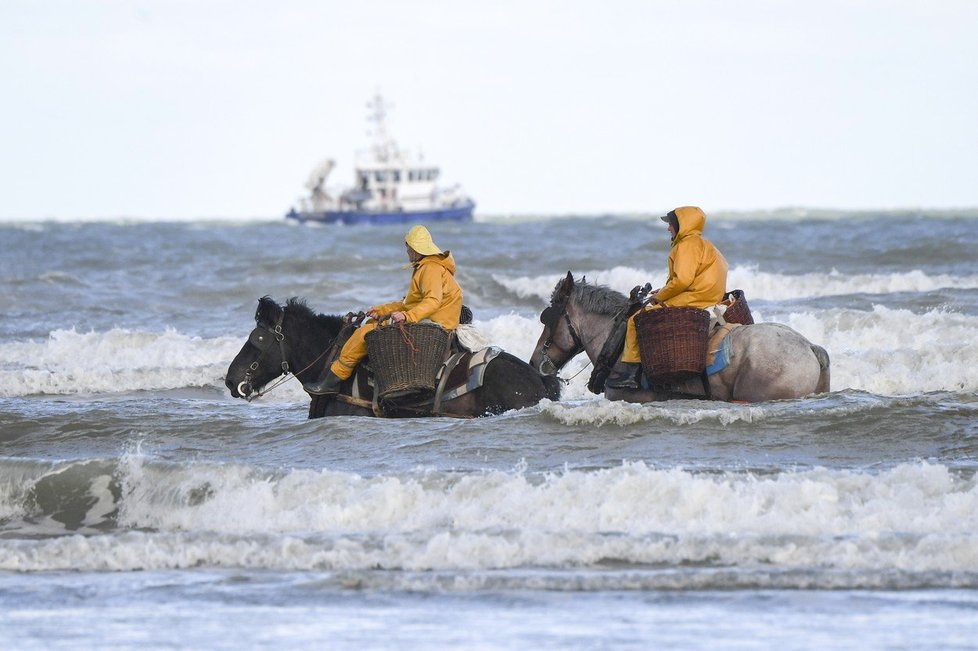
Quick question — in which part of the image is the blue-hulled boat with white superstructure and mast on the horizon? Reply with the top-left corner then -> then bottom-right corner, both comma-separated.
285,94 -> 475,224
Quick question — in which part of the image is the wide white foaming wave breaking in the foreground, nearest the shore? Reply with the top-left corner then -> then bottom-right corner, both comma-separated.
0,454 -> 978,576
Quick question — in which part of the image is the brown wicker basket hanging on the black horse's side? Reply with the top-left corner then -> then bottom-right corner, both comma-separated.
365,323 -> 452,399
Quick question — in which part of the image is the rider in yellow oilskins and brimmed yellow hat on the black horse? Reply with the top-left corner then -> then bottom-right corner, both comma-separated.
303,226 -> 462,395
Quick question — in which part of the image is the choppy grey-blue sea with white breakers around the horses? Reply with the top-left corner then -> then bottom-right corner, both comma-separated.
0,209 -> 978,651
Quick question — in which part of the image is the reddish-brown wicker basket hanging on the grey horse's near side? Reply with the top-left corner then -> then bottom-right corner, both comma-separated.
635,307 -> 710,384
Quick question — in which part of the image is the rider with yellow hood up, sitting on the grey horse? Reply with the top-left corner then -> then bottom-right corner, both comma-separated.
608,206 -> 727,389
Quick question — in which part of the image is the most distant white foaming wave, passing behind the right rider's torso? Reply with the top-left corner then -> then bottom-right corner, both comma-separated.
493,266 -> 978,304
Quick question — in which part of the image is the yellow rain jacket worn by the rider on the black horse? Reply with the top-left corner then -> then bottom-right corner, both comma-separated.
373,251 -> 462,330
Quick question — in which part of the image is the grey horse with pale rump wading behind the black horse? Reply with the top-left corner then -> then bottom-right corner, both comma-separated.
530,272 -> 829,402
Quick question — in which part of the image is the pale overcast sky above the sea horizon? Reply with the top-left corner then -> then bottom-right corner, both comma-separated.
0,0 -> 978,220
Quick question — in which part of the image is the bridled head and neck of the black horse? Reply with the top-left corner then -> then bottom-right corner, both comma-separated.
224,296 -> 342,398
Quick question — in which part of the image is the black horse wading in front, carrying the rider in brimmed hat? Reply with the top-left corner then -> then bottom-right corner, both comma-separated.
224,296 -> 560,418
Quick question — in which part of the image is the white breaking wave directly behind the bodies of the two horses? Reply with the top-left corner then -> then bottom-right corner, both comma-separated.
0,305 -> 978,400
